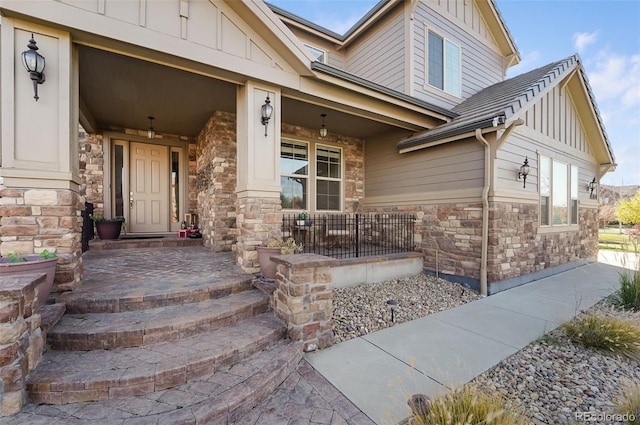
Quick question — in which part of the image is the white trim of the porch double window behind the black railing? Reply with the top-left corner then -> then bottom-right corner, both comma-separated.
278,136 -> 345,214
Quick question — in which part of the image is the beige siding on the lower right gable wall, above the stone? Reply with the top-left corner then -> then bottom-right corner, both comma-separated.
496,86 -> 598,195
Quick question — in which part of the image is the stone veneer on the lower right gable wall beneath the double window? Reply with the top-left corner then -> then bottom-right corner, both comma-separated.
487,202 -> 598,282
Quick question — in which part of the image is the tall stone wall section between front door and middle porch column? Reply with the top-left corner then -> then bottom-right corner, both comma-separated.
196,112 -> 239,252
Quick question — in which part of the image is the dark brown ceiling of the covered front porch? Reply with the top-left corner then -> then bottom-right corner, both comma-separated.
78,45 -> 404,139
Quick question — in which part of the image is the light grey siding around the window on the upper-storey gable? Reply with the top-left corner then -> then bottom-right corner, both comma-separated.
412,1 -> 504,108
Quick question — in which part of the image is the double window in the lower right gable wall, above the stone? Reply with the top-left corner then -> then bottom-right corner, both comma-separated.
538,156 -> 578,226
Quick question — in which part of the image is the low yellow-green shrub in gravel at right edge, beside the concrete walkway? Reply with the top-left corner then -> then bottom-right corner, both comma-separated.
562,313 -> 640,358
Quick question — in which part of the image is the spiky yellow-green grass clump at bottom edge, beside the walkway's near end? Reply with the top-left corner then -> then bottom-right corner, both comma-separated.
409,385 -> 530,425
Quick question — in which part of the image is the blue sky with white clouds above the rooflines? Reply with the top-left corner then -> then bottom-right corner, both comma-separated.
267,0 -> 640,186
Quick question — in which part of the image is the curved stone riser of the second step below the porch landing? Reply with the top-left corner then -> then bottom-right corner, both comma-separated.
27,314 -> 286,405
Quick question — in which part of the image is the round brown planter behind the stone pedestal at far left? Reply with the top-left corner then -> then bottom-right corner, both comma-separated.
0,249 -> 58,305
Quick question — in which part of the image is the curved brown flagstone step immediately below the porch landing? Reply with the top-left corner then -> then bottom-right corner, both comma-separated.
47,289 -> 269,350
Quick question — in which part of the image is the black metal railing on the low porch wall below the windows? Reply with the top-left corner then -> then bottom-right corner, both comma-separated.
282,213 -> 416,258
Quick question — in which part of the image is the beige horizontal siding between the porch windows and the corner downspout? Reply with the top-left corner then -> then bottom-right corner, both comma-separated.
365,139 -> 484,199
